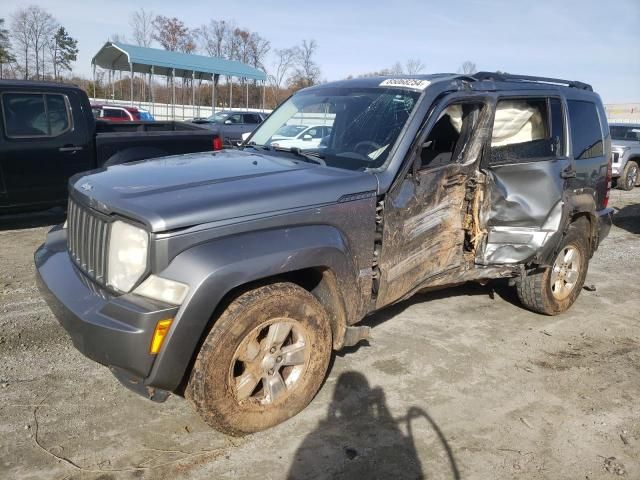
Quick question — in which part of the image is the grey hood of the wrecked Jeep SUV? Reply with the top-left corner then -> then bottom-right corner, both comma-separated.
69,150 -> 377,232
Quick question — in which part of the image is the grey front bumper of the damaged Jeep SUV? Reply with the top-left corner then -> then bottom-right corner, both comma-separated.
34,227 -> 178,400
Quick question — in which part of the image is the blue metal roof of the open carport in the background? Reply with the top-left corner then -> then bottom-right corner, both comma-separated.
91,42 -> 267,80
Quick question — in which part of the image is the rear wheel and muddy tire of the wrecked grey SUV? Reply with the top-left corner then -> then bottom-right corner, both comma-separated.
516,218 -> 589,315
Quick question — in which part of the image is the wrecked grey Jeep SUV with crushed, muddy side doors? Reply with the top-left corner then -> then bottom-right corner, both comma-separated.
35,73 -> 611,435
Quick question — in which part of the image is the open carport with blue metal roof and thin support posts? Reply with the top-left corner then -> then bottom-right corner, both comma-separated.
91,42 -> 267,116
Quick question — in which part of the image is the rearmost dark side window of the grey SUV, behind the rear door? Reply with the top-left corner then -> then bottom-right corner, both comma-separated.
567,100 -> 604,160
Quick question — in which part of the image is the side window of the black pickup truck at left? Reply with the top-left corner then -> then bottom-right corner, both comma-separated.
2,93 -> 71,138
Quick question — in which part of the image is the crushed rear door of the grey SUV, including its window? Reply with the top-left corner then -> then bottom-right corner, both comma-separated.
476,96 -> 575,265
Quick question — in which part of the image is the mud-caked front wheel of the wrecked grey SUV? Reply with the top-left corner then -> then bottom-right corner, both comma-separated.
185,283 -> 332,436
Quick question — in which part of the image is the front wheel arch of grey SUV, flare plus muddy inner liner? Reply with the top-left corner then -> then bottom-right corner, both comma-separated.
145,226 -> 357,391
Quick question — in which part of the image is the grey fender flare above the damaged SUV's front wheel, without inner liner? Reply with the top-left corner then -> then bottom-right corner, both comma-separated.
145,225 -> 359,391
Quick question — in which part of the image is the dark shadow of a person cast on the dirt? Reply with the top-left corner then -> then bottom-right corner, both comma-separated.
287,371 -> 460,480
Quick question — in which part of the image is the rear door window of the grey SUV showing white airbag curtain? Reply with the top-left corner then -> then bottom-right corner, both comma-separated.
491,98 -> 564,165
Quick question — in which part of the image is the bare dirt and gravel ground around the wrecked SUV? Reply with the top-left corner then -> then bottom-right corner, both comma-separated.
0,188 -> 640,480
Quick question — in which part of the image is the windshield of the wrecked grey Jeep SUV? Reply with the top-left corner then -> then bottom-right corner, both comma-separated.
250,87 -> 421,170
